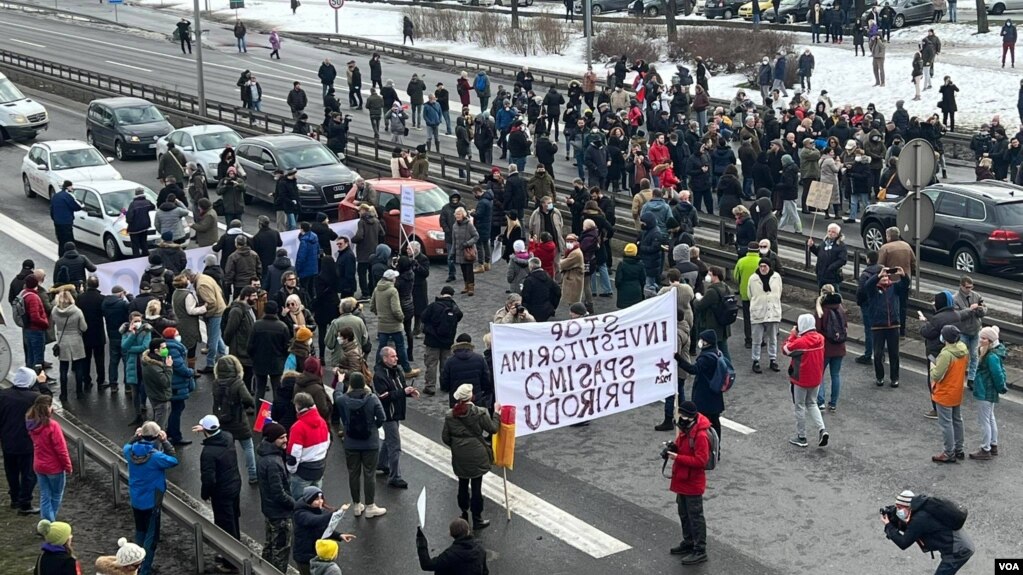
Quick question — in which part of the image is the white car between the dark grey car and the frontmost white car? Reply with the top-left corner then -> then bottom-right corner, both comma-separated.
21,140 -> 121,200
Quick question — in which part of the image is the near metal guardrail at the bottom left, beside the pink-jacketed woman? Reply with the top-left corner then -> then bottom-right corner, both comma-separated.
53,409 -> 280,575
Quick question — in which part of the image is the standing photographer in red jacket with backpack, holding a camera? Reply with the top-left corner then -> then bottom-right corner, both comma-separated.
661,401 -> 711,565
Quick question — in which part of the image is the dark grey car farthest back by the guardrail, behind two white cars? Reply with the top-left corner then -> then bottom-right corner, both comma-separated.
85,97 -> 174,160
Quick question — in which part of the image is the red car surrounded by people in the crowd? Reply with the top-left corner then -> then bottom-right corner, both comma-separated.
338,178 -> 450,258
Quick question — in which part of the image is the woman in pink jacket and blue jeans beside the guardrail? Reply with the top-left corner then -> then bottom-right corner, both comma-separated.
25,395 -> 72,522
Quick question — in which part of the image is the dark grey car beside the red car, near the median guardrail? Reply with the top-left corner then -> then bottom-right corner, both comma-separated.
235,134 -> 359,215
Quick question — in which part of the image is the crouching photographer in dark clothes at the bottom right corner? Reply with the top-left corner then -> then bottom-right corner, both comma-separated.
881,489 -> 973,575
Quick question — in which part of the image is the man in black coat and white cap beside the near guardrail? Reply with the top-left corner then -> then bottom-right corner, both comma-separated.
194,415 -> 241,570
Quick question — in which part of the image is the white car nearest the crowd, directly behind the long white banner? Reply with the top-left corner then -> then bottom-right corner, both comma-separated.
75,180 -> 166,260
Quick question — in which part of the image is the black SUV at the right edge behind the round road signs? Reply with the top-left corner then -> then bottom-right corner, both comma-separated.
859,180 -> 1023,273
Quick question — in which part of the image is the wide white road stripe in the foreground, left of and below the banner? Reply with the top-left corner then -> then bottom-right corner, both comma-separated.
401,419 -> 630,559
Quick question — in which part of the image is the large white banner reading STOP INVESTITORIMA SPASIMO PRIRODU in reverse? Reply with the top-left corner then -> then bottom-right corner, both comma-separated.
490,292 -> 678,437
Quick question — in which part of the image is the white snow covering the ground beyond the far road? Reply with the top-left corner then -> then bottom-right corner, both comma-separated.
142,0 -> 1023,127
